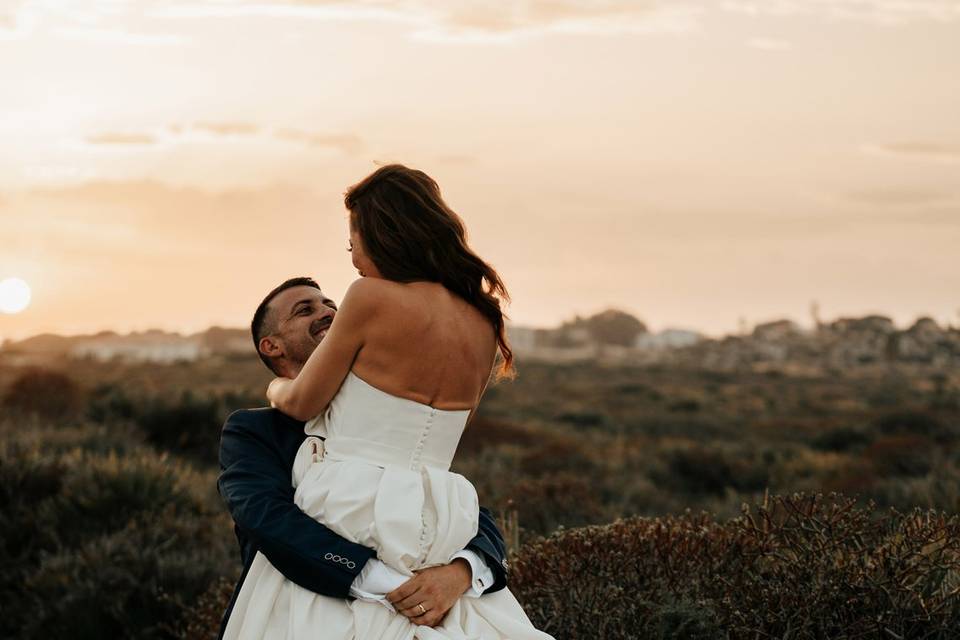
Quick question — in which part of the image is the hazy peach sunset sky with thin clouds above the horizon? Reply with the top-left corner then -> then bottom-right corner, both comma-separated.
0,0 -> 960,339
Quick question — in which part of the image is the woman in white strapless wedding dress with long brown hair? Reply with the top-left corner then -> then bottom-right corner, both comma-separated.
224,165 -> 550,640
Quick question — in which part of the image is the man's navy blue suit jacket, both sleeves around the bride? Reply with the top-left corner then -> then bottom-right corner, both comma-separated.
217,409 -> 507,636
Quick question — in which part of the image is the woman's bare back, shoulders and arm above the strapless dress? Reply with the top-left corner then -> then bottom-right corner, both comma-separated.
267,278 -> 497,420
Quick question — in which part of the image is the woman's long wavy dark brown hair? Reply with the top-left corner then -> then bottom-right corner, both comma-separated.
344,164 -> 513,378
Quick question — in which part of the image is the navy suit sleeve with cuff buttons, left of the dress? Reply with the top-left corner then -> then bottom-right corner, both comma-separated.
217,411 -> 376,598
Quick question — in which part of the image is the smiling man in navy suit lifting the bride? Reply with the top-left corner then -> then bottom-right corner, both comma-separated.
217,278 -> 507,637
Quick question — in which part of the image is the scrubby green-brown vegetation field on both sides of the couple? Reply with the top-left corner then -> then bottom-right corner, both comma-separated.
0,357 -> 960,638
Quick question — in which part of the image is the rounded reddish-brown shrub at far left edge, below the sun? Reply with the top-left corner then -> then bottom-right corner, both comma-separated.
3,368 -> 83,420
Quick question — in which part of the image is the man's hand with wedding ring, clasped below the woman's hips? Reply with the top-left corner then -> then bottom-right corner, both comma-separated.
387,558 -> 473,627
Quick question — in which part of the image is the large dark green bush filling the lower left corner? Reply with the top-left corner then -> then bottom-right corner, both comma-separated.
0,423 -> 232,639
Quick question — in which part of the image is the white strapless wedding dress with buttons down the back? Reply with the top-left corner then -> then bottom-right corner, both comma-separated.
224,371 -> 552,640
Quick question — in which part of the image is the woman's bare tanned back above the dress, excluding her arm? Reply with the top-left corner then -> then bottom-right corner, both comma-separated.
352,279 -> 497,410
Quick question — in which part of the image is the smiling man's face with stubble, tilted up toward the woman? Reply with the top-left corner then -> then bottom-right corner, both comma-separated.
270,287 -> 337,372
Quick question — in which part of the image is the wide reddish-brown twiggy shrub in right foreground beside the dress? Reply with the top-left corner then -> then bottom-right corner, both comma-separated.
511,494 -> 960,640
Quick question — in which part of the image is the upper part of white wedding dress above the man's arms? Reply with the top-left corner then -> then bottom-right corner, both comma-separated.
293,372 -> 479,573
